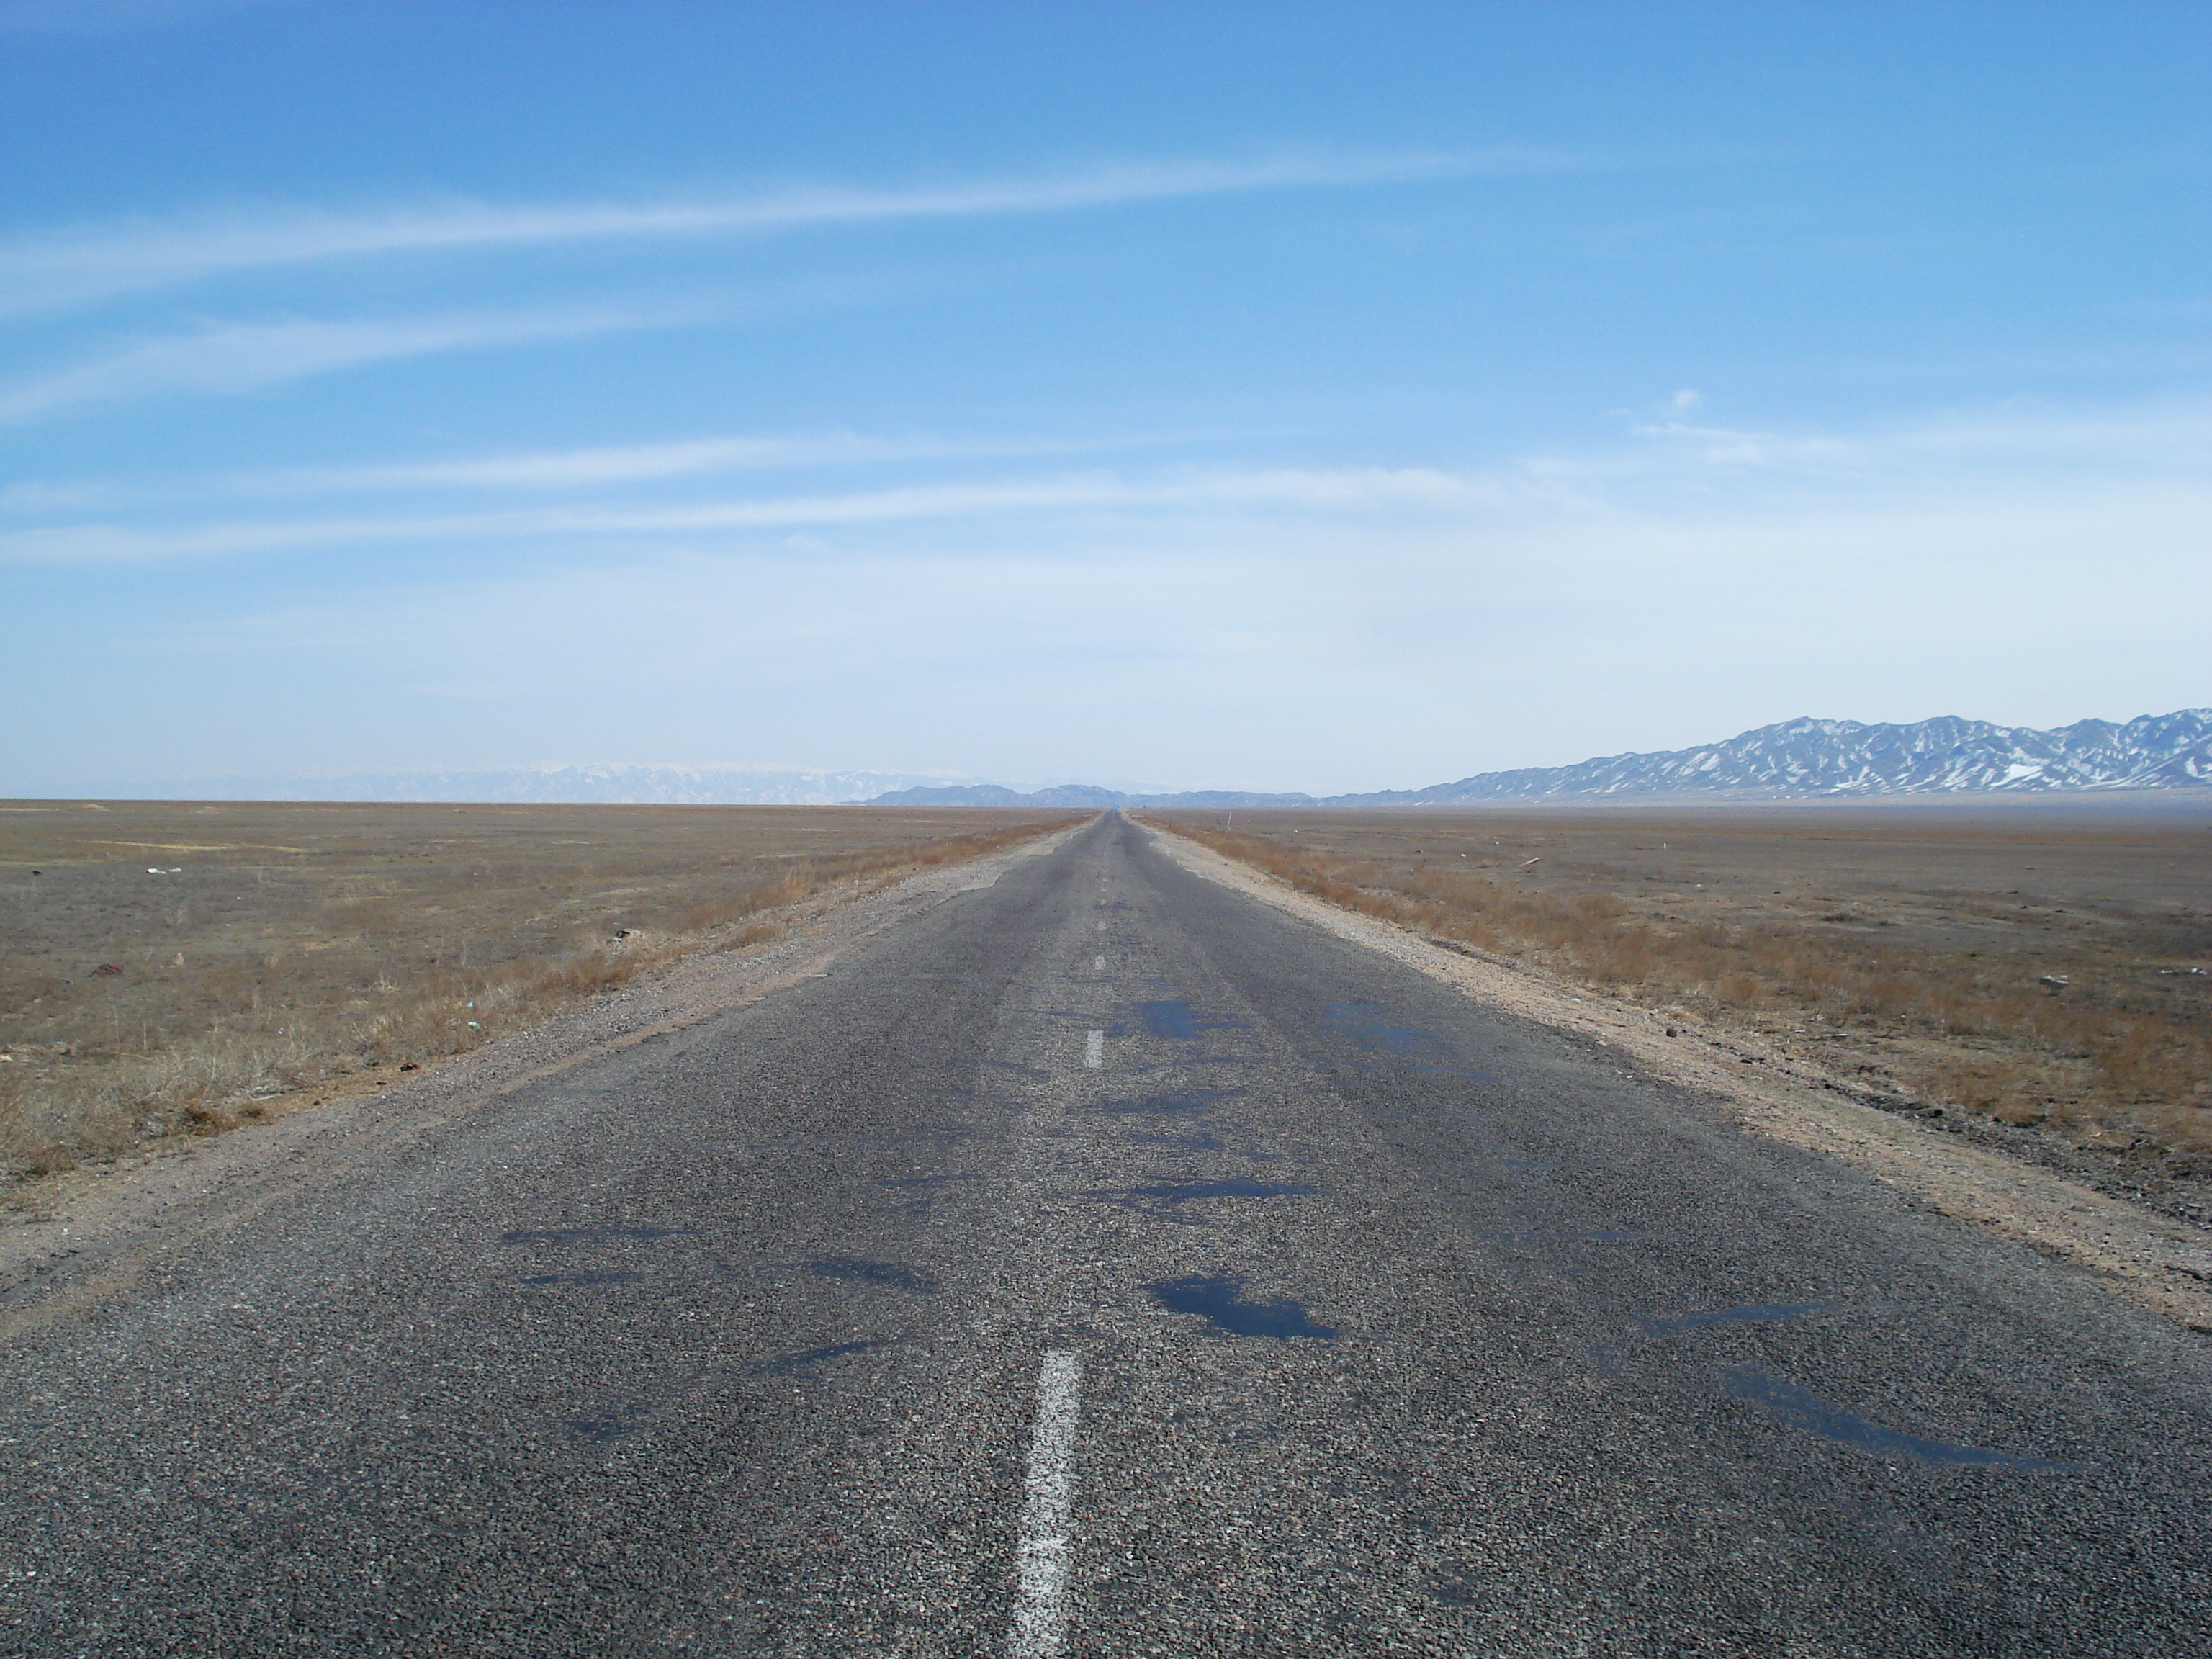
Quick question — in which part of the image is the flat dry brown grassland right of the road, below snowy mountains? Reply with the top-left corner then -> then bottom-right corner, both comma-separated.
1146,803 -> 2212,1159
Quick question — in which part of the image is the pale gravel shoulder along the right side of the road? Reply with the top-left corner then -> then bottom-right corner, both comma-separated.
1148,827 -> 2212,1331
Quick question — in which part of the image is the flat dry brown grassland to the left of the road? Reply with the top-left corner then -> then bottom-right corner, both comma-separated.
0,801 -> 1077,1177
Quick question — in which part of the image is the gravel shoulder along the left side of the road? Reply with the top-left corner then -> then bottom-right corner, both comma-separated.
0,823 -> 1084,1336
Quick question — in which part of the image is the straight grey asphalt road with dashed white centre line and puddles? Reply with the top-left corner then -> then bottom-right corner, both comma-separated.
0,817 -> 2212,1659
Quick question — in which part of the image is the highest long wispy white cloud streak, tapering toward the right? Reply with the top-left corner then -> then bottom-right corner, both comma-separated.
0,148 -> 1599,312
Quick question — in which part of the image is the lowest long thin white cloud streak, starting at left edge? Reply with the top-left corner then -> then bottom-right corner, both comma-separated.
0,467 -> 1502,564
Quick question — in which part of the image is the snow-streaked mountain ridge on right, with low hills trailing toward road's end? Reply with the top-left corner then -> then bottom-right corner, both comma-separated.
876,708 -> 2212,807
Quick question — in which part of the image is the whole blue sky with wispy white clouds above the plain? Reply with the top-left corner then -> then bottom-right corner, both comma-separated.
0,0 -> 2212,794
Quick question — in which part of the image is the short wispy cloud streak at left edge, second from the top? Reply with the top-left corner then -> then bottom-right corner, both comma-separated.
0,310 -> 697,423
